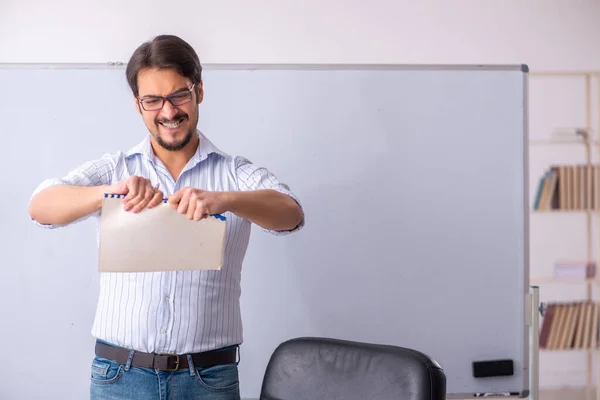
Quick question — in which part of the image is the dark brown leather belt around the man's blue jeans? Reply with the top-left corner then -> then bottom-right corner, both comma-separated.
96,342 -> 237,371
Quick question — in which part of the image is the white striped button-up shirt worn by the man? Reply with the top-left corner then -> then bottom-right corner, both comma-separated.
29,132 -> 304,354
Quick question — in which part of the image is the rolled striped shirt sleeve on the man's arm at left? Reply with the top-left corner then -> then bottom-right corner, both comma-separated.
29,154 -> 116,229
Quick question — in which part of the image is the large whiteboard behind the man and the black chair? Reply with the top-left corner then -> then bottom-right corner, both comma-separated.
0,64 -> 529,399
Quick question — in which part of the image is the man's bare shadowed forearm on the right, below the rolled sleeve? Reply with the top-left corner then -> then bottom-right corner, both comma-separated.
228,189 -> 303,230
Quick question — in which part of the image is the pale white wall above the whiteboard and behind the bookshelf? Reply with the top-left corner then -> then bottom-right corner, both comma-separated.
0,0 -> 600,386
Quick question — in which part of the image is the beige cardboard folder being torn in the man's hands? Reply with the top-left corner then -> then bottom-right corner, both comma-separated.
98,194 -> 227,272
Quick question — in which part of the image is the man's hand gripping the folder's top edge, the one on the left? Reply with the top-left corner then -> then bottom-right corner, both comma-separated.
106,176 -> 164,213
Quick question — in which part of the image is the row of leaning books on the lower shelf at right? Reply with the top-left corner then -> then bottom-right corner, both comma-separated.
539,301 -> 599,350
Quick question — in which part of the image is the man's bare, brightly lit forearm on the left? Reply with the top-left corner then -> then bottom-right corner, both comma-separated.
29,185 -> 106,225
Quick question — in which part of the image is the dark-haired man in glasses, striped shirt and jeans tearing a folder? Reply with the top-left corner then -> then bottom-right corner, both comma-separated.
29,35 -> 304,400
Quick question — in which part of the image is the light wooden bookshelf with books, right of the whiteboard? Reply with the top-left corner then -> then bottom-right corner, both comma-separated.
529,71 -> 600,400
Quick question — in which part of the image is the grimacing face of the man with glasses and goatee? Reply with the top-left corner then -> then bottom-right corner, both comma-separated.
135,68 -> 203,151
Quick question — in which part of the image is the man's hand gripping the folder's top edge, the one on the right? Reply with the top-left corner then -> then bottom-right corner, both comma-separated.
168,187 -> 228,221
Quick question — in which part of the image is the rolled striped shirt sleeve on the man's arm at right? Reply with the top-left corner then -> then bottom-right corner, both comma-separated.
235,157 -> 304,235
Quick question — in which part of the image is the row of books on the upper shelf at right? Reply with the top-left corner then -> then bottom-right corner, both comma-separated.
533,164 -> 600,211
